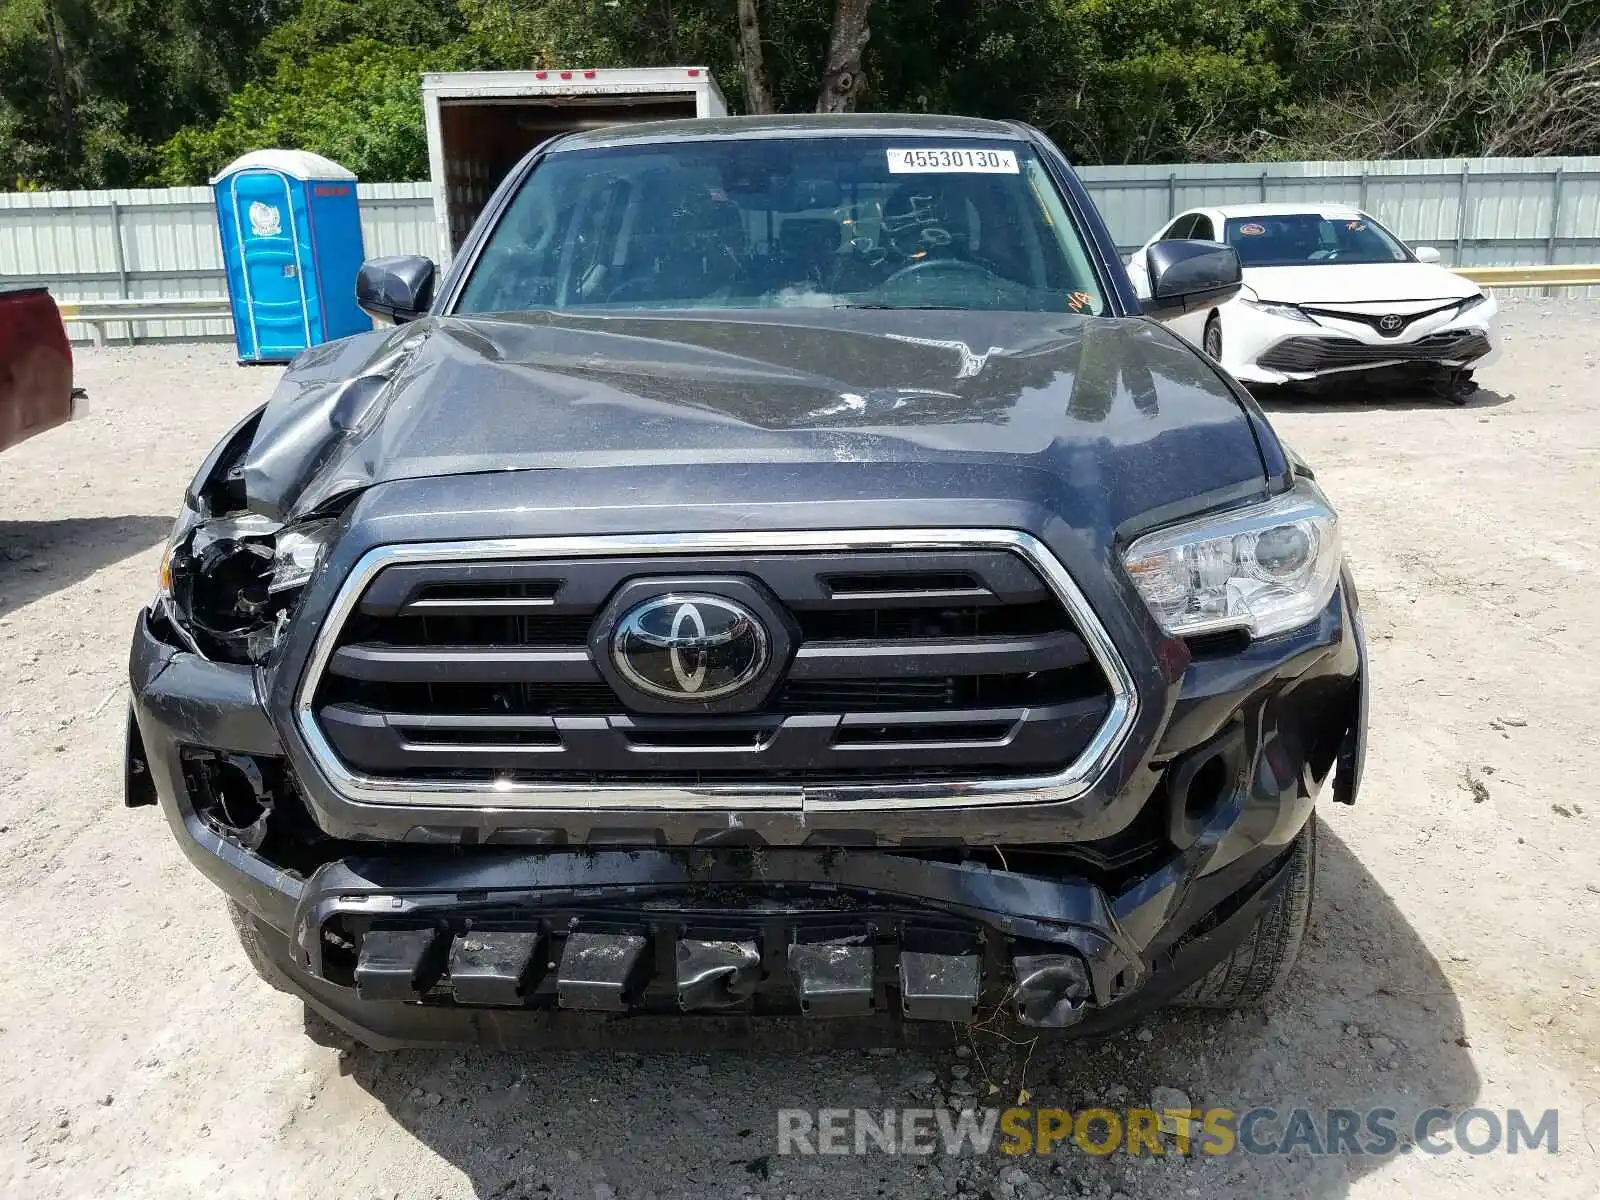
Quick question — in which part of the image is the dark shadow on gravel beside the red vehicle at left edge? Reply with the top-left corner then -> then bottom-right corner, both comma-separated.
0,517 -> 173,616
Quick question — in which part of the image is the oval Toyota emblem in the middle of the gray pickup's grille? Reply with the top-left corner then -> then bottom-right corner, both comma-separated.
611,595 -> 771,702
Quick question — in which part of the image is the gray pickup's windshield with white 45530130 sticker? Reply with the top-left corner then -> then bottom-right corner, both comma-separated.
456,138 -> 1102,314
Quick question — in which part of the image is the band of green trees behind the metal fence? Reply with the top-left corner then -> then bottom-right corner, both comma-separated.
12,0 -> 1600,187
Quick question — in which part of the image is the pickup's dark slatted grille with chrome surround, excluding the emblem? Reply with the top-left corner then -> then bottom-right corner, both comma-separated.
299,531 -> 1133,805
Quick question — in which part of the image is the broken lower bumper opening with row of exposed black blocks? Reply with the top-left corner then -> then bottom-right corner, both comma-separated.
282,850 -> 1144,1032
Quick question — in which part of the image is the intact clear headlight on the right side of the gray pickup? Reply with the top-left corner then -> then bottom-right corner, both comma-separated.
1123,480 -> 1341,637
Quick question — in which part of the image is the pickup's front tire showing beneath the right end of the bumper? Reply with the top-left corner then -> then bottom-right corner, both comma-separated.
1173,813 -> 1317,1008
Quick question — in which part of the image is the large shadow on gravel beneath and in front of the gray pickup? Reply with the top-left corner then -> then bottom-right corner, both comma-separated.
341,826 -> 1478,1200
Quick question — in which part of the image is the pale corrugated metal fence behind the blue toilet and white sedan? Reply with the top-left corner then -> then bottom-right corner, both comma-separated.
0,157 -> 1600,338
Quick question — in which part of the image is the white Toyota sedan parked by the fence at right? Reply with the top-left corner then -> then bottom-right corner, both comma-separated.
1128,205 -> 1499,394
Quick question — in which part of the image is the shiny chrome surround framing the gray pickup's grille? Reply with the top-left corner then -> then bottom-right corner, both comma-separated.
294,528 -> 1139,814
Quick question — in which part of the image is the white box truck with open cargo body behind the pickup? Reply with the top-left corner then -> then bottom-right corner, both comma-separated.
422,67 -> 728,267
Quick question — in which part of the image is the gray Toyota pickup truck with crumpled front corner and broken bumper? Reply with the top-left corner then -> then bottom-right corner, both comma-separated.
128,117 -> 1366,1045
